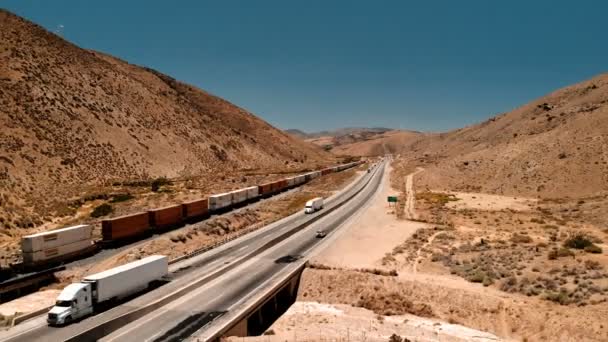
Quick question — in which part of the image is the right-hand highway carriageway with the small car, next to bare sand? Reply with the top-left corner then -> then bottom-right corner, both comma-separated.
102,162 -> 383,342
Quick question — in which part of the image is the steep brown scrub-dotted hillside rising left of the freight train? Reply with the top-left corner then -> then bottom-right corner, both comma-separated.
0,10 -> 332,227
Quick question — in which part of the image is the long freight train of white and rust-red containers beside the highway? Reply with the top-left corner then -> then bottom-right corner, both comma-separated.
18,162 -> 363,270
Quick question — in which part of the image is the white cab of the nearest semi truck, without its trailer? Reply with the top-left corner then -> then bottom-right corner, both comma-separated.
46,283 -> 93,325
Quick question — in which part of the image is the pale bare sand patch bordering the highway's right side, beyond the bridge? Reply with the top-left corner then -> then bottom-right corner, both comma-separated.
311,166 -> 425,268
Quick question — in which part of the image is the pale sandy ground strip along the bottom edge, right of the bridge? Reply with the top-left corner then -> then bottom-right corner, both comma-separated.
229,302 -> 500,342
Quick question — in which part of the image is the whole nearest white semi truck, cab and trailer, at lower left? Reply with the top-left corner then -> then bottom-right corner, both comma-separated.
47,255 -> 169,325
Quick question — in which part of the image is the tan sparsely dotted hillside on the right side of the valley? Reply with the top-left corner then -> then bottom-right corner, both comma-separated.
399,74 -> 608,198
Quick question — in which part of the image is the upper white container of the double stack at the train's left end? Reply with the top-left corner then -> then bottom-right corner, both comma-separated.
21,224 -> 93,253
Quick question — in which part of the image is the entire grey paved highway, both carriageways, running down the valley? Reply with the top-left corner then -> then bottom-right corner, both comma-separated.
0,161 -> 382,342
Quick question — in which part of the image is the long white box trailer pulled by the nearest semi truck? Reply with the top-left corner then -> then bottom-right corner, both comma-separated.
82,255 -> 169,303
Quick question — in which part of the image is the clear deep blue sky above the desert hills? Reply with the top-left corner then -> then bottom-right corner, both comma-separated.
0,0 -> 608,131
